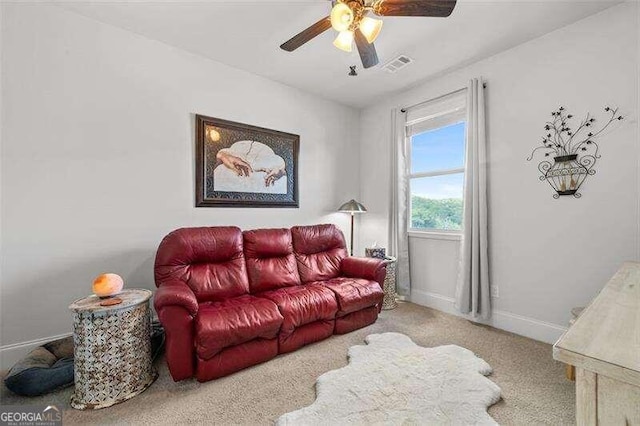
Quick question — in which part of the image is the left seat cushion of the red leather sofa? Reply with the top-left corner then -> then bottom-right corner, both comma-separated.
195,295 -> 283,360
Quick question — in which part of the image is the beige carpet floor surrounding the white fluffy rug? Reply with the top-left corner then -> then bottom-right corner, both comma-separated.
0,303 -> 575,426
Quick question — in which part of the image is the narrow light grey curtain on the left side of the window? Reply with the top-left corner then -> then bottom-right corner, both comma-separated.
389,109 -> 411,297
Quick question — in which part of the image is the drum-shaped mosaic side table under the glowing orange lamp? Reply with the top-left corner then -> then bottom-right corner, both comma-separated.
69,289 -> 158,410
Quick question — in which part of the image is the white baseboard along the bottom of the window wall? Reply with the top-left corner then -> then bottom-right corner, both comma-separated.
411,290 -> 567,344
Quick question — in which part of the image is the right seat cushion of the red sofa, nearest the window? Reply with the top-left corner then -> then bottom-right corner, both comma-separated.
317,277 -> 384,317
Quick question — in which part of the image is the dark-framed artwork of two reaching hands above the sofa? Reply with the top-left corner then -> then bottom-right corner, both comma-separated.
196,115 -> 300,208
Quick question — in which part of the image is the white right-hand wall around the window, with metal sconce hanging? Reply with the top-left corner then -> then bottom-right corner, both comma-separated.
360,2 -> 640,341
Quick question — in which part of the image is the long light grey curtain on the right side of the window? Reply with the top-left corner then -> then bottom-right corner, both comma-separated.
456,79 -> 491,319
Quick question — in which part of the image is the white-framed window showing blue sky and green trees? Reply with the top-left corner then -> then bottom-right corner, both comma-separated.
406,91 -> 466,232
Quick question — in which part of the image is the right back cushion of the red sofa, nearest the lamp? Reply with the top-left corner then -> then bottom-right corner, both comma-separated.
291,225 -> 347,283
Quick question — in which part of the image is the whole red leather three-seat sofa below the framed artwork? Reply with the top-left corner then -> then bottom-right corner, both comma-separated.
154,225 -> 386,382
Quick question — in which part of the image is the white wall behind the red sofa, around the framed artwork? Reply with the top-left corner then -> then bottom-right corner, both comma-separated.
0,3 -> 359,365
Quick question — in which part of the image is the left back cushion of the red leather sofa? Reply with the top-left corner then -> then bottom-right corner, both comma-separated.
155,226 -> 249,302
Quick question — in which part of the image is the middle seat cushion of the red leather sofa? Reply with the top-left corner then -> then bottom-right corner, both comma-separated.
257,284 -> 338,334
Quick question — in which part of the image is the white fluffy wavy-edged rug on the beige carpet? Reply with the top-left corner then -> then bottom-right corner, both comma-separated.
277,333 -> 500,425
